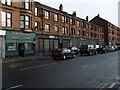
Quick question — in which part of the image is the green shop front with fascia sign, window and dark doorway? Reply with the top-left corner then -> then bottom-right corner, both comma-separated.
5,30 -> 35,57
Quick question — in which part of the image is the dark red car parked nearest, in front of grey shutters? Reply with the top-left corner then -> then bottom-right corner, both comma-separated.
52,48 -> 75,59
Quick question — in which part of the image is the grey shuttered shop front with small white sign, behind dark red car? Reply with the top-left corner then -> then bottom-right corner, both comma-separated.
35,34 -> 69,54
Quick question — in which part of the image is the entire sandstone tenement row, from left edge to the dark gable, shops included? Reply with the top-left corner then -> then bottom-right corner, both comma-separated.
0,0 -> 104,58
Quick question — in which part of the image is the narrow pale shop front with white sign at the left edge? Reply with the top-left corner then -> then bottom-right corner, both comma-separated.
0,30 -> 6,59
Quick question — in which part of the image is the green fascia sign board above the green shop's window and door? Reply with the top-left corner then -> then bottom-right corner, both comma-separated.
6,31 -> 35,41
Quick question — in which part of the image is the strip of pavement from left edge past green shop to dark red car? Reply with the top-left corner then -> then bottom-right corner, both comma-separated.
1,54 -> 52,63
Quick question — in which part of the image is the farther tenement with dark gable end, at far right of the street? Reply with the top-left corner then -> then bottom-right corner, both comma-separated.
90,14 -> 120,45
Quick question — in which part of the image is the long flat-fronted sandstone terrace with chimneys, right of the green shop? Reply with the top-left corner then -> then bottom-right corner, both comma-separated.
34,2 -> 104,53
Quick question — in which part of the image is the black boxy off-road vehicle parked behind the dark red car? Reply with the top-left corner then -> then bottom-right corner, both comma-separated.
80,45 -> 97,56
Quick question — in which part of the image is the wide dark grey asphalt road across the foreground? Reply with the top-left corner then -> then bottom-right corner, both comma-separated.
2,51 -> 119,90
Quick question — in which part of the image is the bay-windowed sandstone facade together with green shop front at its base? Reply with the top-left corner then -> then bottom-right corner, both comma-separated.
0,0 -> 35,58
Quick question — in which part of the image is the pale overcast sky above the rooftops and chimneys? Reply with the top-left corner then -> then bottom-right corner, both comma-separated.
34,0 -> 119,26
